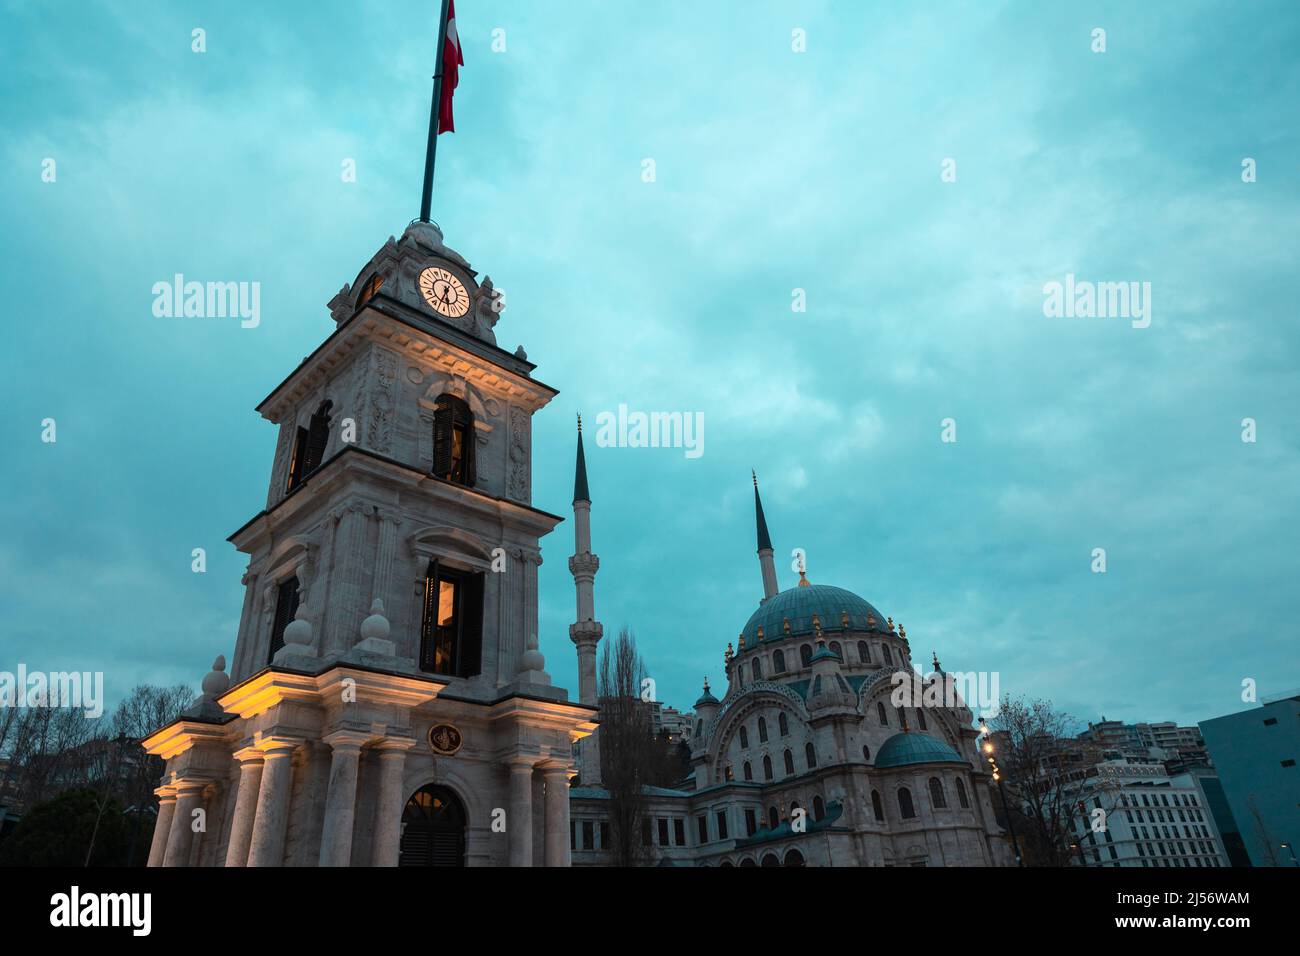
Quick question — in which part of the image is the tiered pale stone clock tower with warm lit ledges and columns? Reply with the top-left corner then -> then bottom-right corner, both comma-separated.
144,221 -> 595,866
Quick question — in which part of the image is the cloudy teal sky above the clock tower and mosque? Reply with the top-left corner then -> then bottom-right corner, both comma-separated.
0,0 -> 1300,722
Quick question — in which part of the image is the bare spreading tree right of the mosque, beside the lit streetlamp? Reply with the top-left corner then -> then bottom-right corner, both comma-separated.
988,695 -> 1119,866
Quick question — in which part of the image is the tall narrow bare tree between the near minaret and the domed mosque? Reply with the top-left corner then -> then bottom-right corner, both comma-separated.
597,628 -> 654,866
